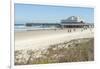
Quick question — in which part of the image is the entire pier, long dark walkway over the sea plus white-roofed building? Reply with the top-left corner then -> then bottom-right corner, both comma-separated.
26,16 -> 94,29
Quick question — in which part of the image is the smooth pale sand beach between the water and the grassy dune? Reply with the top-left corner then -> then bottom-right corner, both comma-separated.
15,29 -> 94,50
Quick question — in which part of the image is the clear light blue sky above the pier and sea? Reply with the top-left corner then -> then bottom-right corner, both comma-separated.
14,3 -> 94,24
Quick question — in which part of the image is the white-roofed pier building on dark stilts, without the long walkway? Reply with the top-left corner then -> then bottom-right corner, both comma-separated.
61,16 -> 94,28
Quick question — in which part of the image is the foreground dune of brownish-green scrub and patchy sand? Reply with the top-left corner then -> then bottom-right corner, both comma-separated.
15,38 -> 94,65
